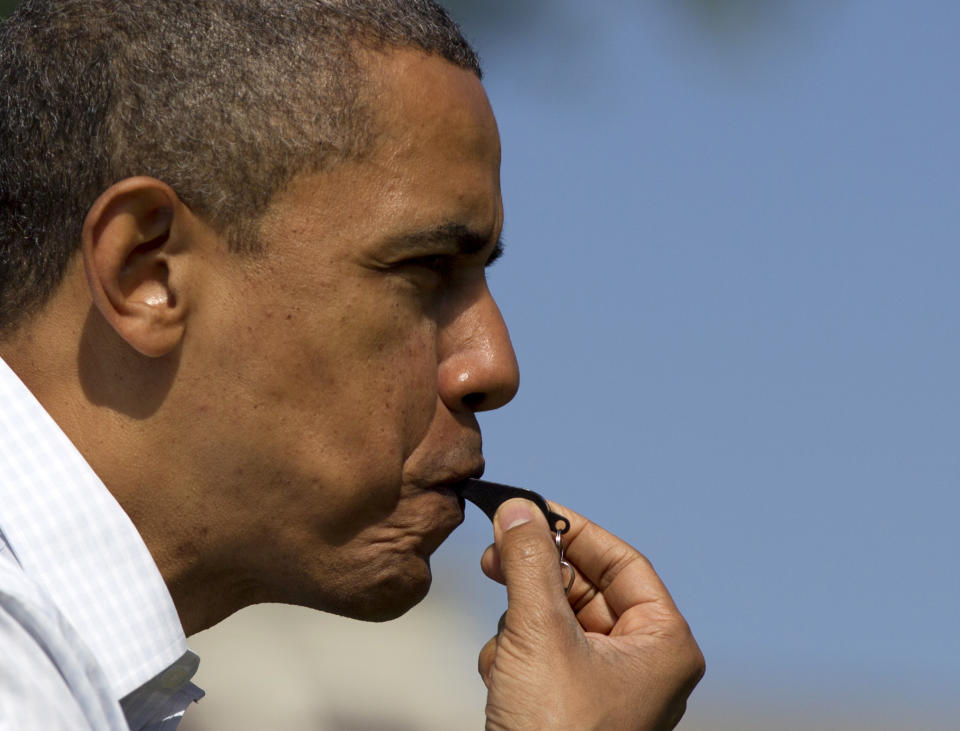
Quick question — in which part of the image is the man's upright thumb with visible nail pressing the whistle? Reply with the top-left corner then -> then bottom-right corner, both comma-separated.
493,498 -> 571,634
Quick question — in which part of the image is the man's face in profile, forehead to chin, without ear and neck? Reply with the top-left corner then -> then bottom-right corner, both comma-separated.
185,50 -> 518,619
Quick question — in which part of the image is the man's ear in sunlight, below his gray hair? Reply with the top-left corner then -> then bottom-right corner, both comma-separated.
82,177 -> 189,357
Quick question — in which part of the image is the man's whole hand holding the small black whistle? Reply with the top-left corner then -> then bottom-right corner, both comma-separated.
479,499 -> 704,731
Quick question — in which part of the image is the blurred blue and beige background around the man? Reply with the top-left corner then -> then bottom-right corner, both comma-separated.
0,0 -> 960,731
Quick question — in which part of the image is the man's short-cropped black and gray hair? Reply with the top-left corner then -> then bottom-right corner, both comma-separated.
0,0 -> 481,334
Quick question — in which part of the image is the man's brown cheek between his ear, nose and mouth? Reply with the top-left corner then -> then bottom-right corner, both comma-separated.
204,278 -> 446,541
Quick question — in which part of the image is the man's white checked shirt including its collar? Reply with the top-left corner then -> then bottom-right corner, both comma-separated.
0,360 -> 203,731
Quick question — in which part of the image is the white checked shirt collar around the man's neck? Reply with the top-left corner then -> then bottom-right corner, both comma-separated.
0,359 -> 195,700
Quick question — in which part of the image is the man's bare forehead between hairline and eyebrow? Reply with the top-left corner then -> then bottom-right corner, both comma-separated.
262,49 -> 502,250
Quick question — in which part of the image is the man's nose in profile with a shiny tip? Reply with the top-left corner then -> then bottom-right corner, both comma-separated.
438,284 -> 520,411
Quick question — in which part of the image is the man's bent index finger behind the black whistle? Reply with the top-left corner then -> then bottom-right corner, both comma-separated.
548,501 -> 677,615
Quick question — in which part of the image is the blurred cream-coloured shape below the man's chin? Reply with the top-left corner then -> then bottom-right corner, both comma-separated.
180,596 -> 493,731
